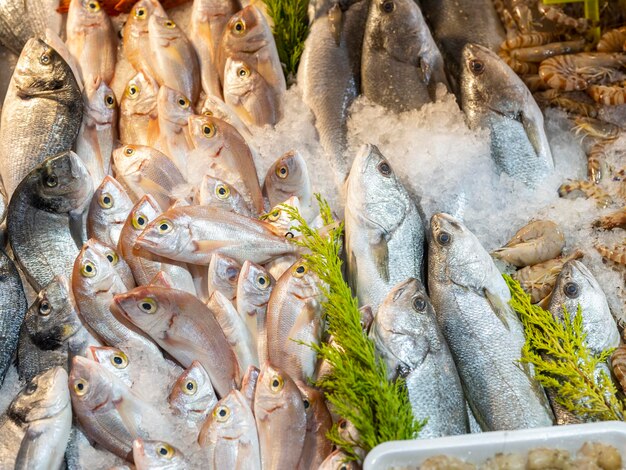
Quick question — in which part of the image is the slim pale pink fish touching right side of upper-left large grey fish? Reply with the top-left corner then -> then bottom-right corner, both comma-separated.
74,76 -> 118,186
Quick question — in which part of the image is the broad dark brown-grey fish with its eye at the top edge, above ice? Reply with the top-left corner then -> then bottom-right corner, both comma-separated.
361,0 -> 447,112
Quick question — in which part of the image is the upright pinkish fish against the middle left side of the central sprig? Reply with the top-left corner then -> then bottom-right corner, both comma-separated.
266,260 -> 324,382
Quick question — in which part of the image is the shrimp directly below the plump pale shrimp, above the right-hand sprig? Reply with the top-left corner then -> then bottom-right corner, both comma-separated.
511,250 -> 584,304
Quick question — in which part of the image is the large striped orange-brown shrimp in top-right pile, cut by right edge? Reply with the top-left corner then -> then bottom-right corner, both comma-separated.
539,52 -> 626,91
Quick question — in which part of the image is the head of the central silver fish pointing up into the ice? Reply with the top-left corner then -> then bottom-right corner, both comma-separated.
346,144 -> 411,233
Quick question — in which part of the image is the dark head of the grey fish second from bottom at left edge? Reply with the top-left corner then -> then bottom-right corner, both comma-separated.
24,276 -> 82,350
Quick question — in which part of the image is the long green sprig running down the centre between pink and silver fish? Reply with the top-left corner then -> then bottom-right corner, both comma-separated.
282,194 -> 425,460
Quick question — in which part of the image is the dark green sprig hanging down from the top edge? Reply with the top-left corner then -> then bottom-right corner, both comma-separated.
263,0 -> 309,81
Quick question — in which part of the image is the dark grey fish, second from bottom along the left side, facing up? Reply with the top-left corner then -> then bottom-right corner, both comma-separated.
17,276 -> 96,381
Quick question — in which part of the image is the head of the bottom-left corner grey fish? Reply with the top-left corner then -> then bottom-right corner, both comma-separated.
9,366 -> 70,423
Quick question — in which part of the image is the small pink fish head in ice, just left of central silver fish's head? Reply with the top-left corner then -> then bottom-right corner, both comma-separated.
264,150 -> 310,201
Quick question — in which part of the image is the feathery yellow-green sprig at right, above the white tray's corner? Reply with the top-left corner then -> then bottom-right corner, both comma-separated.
504,274 -> 626,421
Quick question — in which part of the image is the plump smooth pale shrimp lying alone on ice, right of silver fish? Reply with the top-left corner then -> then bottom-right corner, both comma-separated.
491,220 -> 565,267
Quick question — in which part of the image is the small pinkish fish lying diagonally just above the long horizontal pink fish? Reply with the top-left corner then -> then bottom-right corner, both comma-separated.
113,145 -> 186,209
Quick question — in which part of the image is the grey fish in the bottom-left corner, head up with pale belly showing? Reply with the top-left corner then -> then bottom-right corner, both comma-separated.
0,367 -> 72,470
